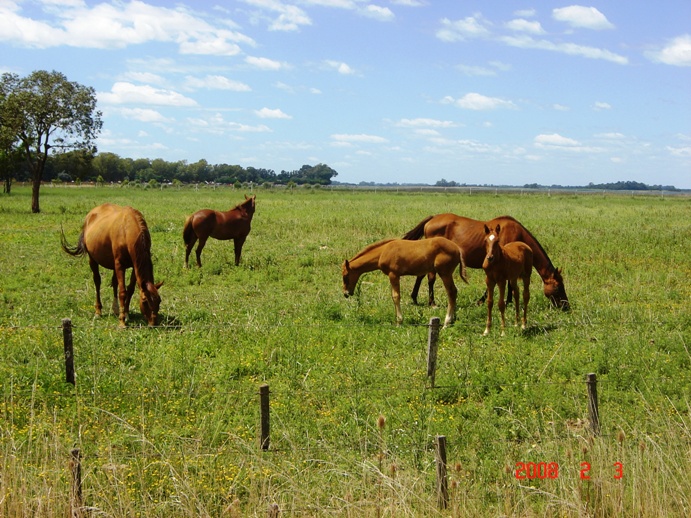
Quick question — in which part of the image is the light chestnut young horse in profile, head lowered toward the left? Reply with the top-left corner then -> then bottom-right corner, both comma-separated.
343,237 -> 468,326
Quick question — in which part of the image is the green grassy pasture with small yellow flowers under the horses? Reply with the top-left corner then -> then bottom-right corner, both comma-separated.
0,186 -> 691,517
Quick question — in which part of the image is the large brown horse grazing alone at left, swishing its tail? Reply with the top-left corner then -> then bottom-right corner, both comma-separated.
61,203 -> 163,327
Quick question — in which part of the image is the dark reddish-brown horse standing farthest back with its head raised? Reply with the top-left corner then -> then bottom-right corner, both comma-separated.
182,195 -> 257,268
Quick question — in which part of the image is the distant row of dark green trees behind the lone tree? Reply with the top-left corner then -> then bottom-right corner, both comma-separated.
5,151 -> 338,185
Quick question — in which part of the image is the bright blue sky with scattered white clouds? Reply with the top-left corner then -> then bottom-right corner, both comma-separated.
0,0 -> 691,189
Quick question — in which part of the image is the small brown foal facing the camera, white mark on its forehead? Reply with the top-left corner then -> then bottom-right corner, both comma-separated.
482,224 -> 533,336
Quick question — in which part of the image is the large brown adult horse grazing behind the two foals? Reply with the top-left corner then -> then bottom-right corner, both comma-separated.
403,213 -> 571,311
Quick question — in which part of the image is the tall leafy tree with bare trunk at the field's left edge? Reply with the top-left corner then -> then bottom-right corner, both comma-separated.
0,70 -> 103,213
